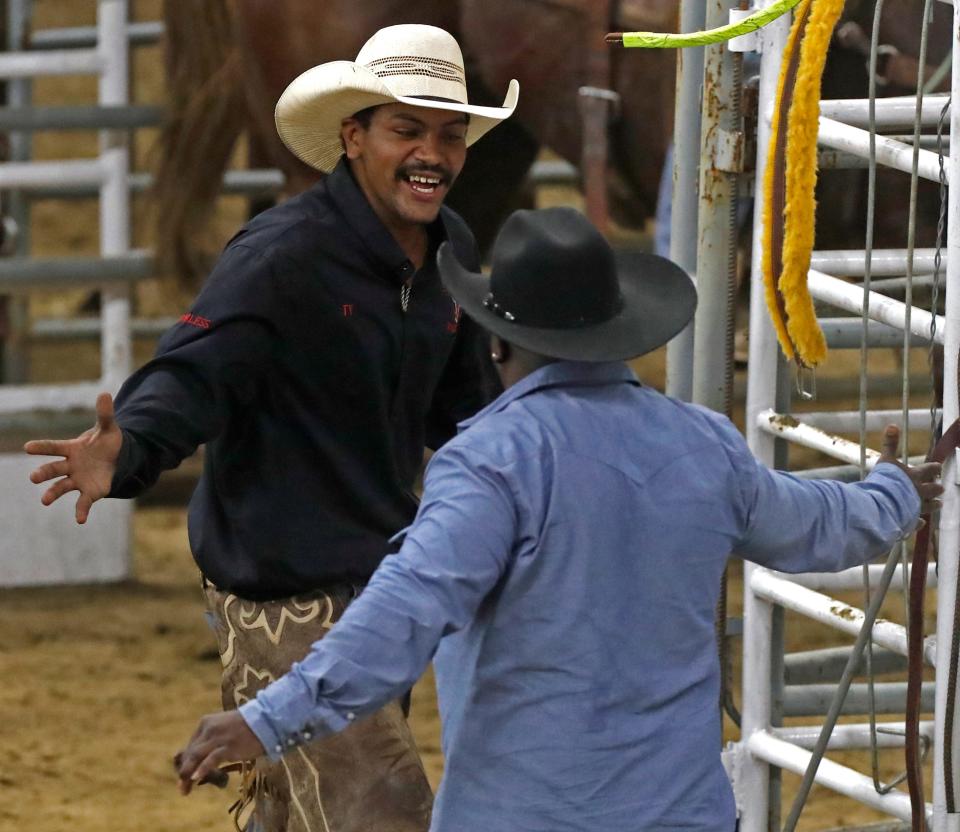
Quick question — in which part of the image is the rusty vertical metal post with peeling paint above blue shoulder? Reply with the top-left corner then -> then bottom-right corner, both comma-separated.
693,0 -> 743,413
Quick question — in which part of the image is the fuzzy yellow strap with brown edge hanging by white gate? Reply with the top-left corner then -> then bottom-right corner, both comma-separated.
763,0 -> 843,367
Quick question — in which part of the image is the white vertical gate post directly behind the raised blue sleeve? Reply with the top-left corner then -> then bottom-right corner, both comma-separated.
738,0 -> 790,832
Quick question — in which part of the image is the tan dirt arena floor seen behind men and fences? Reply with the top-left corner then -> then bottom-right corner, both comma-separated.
0,0 -> 932,832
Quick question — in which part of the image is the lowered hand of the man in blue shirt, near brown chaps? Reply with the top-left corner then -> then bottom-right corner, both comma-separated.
174,711 -> 264,794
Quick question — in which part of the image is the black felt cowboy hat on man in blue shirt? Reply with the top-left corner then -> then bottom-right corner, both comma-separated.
437,208 -> 697,361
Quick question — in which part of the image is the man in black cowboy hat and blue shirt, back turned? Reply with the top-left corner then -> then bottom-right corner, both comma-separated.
172,208 -> 942,832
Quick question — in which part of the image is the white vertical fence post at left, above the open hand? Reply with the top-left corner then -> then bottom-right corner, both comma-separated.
97,0 -> 131,392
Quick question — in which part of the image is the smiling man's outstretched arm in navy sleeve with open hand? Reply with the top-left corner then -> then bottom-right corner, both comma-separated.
25,246 -> 276,523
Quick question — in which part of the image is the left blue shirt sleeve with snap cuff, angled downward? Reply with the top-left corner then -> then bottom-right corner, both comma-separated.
240,443 -> 517,758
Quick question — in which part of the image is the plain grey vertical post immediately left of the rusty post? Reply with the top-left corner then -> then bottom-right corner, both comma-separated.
667,0 -> 707,401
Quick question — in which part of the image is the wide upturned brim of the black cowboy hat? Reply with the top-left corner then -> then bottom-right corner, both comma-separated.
437,243 -> 697,361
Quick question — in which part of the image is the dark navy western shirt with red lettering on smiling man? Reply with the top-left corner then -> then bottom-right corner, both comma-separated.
111,162 -> 498,599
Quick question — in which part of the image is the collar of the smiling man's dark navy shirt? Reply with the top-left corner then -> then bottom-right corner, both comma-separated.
324,156 -> 449,283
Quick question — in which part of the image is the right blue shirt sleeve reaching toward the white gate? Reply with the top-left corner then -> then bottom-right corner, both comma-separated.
722,425 -> 920,572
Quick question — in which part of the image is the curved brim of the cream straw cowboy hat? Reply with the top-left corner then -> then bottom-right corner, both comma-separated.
274,61 -> 520,173
